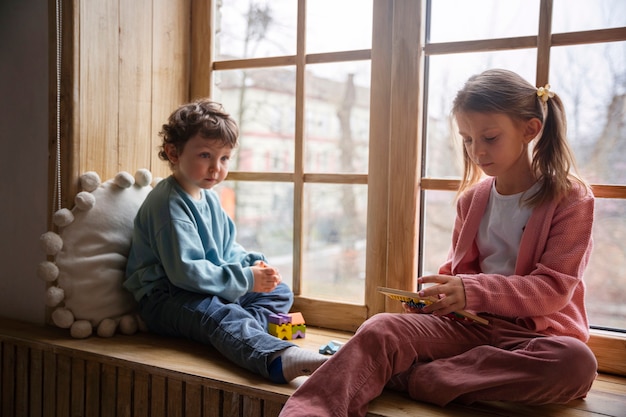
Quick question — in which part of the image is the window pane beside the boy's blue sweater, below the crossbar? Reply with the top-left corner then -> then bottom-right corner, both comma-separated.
215,181 -> 293,286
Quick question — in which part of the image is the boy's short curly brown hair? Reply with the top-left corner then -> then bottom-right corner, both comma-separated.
159,98 -> 239,166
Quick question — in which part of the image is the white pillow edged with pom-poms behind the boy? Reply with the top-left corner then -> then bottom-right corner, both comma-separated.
38,169 -> 152,338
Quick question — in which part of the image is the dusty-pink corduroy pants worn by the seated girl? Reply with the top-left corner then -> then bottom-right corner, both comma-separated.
280,313 -> 597,417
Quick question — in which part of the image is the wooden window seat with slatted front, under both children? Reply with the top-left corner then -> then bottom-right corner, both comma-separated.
0,318 -> 626,417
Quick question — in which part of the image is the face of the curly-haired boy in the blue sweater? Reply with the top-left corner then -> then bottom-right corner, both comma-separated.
165,135 -> 233,199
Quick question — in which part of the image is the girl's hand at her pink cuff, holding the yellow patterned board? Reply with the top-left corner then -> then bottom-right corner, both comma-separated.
417,275 -> 465,316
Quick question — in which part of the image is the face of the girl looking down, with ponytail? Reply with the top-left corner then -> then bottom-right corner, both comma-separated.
456,112 -> 541,191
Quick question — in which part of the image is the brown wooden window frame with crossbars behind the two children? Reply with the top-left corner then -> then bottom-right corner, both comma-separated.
190,0 -> 626,375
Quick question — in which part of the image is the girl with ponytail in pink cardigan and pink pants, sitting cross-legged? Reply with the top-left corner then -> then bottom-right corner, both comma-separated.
281,70 -> 597,417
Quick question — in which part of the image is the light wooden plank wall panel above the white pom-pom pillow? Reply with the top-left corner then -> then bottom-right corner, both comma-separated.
62,0 -> 191,188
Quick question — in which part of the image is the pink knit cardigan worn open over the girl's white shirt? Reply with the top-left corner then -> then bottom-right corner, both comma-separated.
439,178 -> 594,342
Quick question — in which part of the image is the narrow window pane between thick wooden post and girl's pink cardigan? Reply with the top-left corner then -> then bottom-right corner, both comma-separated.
419,190 -> 456,275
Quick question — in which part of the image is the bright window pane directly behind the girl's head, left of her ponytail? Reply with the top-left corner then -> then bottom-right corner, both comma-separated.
426,49 -> 536,178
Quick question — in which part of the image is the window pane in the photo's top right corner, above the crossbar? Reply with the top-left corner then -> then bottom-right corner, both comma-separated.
552,0 -> 626,33
